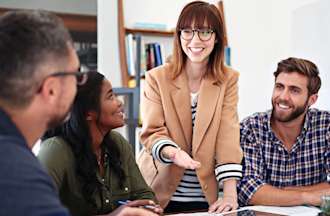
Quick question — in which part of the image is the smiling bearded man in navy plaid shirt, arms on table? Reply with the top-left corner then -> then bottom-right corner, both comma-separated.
238,58 -> 330,206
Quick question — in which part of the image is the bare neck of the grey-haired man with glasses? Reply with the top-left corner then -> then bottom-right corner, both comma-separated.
4,104 -> 47,149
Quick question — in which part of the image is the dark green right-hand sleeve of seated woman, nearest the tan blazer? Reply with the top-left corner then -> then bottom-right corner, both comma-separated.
113,134 -> 157,201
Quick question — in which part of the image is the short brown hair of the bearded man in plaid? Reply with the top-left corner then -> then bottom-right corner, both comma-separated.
274,57 -> 321,95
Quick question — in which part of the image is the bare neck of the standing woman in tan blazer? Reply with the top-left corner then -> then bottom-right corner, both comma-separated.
185,62 -> 207,92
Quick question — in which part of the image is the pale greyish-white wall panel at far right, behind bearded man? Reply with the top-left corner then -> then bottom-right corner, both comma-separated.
291,0 -> 330,110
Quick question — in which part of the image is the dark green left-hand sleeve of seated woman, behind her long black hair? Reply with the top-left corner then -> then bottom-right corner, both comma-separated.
37,137 -> 70,190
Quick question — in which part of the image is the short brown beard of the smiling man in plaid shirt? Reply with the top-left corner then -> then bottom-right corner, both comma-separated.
272,99 -> 308,122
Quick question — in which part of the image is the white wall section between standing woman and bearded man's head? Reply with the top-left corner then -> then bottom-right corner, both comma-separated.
224,0 -> 290,119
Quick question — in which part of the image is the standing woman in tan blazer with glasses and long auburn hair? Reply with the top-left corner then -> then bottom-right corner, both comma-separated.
138,1 -> 242,212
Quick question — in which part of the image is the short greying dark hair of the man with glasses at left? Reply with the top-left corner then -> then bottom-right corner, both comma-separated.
0,10 -> 72,107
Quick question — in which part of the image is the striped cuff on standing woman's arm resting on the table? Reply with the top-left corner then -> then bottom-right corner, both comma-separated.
215,163 -> 242,183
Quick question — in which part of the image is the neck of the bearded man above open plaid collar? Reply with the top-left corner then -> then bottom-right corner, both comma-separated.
271,113 -> 306,151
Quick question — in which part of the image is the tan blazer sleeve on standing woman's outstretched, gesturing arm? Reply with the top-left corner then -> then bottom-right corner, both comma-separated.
140,71 -> 176,153
